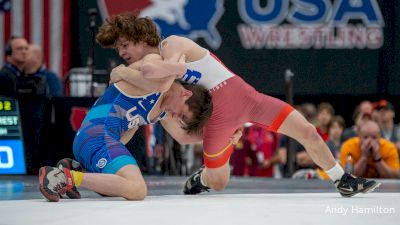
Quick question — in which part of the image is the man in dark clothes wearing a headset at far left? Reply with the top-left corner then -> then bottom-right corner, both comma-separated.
0,37 -> 28,98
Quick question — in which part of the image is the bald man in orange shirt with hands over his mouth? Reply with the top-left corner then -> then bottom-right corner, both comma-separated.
340,121 -> 400,178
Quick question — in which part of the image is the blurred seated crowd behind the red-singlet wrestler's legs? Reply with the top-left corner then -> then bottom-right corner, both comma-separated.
231,100 -> 400,179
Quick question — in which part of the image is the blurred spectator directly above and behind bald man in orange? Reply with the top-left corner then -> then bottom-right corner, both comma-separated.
342,101 -> 374,142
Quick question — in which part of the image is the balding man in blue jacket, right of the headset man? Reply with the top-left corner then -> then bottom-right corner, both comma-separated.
24,44 -> 63,97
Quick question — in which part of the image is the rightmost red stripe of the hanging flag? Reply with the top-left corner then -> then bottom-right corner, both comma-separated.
63,0 -> 71,78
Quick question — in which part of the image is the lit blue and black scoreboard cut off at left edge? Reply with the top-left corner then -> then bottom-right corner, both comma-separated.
0,96 -> 26,174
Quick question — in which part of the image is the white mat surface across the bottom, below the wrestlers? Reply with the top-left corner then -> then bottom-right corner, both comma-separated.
0,193 -> 400,225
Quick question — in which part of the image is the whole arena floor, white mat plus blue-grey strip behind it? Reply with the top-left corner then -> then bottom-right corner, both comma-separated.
0,176 -> 400,225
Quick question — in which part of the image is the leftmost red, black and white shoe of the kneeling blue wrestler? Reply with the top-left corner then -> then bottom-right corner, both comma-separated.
39,166 -> 74,202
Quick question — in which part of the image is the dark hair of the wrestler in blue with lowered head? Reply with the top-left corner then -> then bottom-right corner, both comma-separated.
181,83 -> 213,134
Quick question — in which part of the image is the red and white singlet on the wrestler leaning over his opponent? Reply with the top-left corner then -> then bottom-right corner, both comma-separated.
181,51 -> 293,168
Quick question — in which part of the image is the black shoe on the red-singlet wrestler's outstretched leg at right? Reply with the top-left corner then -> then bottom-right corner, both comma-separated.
335,173 -> 381,197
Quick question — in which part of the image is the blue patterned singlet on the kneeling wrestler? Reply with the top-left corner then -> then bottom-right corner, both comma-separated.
73,84 -> 166,174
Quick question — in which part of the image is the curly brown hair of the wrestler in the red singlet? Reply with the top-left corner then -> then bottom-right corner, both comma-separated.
96,12 -> 161,48
